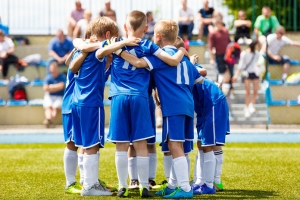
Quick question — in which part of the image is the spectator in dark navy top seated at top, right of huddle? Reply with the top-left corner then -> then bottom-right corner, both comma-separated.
198,0 -> 215,42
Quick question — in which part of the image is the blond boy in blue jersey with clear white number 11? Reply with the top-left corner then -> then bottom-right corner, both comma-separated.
121,20 -> 203,199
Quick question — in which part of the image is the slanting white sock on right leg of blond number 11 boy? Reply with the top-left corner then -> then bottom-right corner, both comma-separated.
173,156 -> 191,192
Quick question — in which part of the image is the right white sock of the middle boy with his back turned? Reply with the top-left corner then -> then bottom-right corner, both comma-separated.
136,156 -> 149,190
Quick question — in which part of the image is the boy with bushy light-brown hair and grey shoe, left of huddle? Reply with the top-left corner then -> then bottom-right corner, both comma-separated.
70,17 -> 141,196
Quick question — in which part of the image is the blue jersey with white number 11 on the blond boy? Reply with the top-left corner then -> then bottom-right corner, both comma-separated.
144,46 -> 203,118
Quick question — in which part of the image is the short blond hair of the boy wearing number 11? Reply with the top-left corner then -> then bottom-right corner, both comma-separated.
154,19 -> 178,43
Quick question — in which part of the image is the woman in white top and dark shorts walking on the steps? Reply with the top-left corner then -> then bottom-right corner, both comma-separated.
232,41 -> 262,118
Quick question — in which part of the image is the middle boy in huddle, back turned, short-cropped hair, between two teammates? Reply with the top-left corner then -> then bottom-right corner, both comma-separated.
107,10 -> 184,197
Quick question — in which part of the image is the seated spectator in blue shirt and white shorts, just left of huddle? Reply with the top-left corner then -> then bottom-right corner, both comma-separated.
43,61 -> 66,128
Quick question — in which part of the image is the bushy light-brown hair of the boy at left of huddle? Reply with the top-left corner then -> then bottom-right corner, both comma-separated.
91,17 -> 119,37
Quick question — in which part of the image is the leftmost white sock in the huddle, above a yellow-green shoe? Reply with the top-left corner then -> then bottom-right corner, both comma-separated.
64,147 -> 78,186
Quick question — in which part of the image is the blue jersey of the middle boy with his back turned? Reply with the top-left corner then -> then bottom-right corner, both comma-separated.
109,40 -> 161,98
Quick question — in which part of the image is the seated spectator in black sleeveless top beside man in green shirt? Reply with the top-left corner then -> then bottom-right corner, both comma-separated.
234,10 -> 252,44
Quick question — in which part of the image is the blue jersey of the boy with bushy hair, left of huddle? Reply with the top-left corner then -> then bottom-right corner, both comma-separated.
73,42 -> 106,107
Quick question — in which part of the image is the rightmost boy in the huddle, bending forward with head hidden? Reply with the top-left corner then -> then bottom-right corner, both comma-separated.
192,66 -> 230,194
